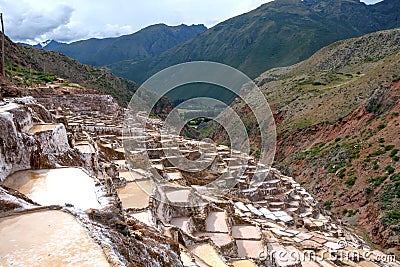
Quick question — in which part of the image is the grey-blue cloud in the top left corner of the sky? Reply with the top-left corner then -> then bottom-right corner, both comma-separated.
0,0 -> 74,40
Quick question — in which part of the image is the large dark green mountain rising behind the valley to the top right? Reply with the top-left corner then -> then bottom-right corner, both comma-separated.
108,0 -> 400,86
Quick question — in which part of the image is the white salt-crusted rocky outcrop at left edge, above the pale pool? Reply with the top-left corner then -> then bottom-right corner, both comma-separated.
0,98 -> 84,181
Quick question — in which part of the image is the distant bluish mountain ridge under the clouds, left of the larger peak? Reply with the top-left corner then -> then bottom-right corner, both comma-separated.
50,24 -> 207,67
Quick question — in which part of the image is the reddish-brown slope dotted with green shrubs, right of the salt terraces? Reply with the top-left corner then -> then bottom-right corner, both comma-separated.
203,29 -> 400,253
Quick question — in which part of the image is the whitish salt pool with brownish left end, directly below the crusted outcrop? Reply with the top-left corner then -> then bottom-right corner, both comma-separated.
3,168 -> 101,210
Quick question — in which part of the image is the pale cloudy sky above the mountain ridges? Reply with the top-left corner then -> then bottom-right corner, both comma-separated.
0,0 -> 380,43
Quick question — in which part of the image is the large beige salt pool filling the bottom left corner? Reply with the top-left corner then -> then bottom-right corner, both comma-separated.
0,211 -> 110,266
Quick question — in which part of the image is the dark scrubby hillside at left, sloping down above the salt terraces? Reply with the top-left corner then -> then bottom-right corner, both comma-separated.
1,35 -> 138,106
